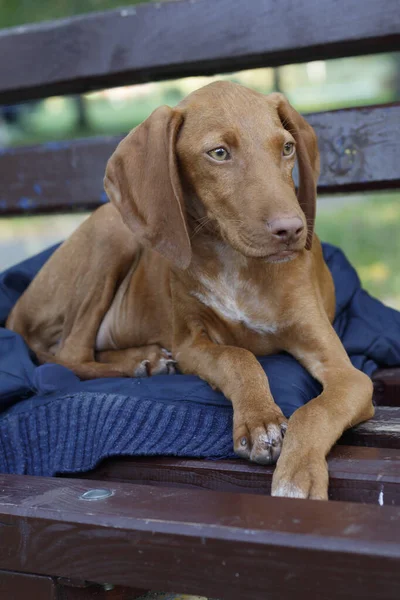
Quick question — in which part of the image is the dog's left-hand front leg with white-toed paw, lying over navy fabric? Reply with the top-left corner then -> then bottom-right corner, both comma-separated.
174,333 -> 286,464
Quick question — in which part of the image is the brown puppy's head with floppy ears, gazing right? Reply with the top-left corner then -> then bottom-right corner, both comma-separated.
104,82 -> 319,268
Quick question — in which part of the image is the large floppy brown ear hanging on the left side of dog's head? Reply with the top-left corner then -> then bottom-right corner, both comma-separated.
104,106 -> 191,269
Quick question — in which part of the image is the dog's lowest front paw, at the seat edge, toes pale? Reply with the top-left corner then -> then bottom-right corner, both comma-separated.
271,453 -> 329,500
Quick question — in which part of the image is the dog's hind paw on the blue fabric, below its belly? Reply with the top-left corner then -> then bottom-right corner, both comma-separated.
96,344 -> 175,377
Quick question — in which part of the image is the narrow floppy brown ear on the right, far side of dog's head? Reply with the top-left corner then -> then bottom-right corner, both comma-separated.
268,93 -> 320,250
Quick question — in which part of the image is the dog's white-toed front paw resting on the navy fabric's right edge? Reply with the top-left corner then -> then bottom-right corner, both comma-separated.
233,407 -> 287,465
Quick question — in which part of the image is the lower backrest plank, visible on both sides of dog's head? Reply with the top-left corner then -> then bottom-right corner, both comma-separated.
0,104 -> 400,216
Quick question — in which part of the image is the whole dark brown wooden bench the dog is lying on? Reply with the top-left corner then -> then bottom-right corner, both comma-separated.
0,0 -> 400,600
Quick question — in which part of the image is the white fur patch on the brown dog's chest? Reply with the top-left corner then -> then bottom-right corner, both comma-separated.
193,265 -> 279,334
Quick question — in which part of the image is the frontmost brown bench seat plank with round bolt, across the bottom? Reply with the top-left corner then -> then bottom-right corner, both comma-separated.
0,476 -> 400,600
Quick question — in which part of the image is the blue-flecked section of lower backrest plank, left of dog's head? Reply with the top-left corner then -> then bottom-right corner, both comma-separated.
0,137 -> 116,216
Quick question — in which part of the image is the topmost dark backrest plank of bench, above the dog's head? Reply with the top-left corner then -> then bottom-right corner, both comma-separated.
0,0 -> 400,103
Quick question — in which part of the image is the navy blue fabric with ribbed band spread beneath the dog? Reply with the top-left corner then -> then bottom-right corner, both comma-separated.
0,244 -> 400,475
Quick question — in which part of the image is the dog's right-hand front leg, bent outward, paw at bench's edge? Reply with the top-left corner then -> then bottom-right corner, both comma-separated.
272,317 -> 374,499
